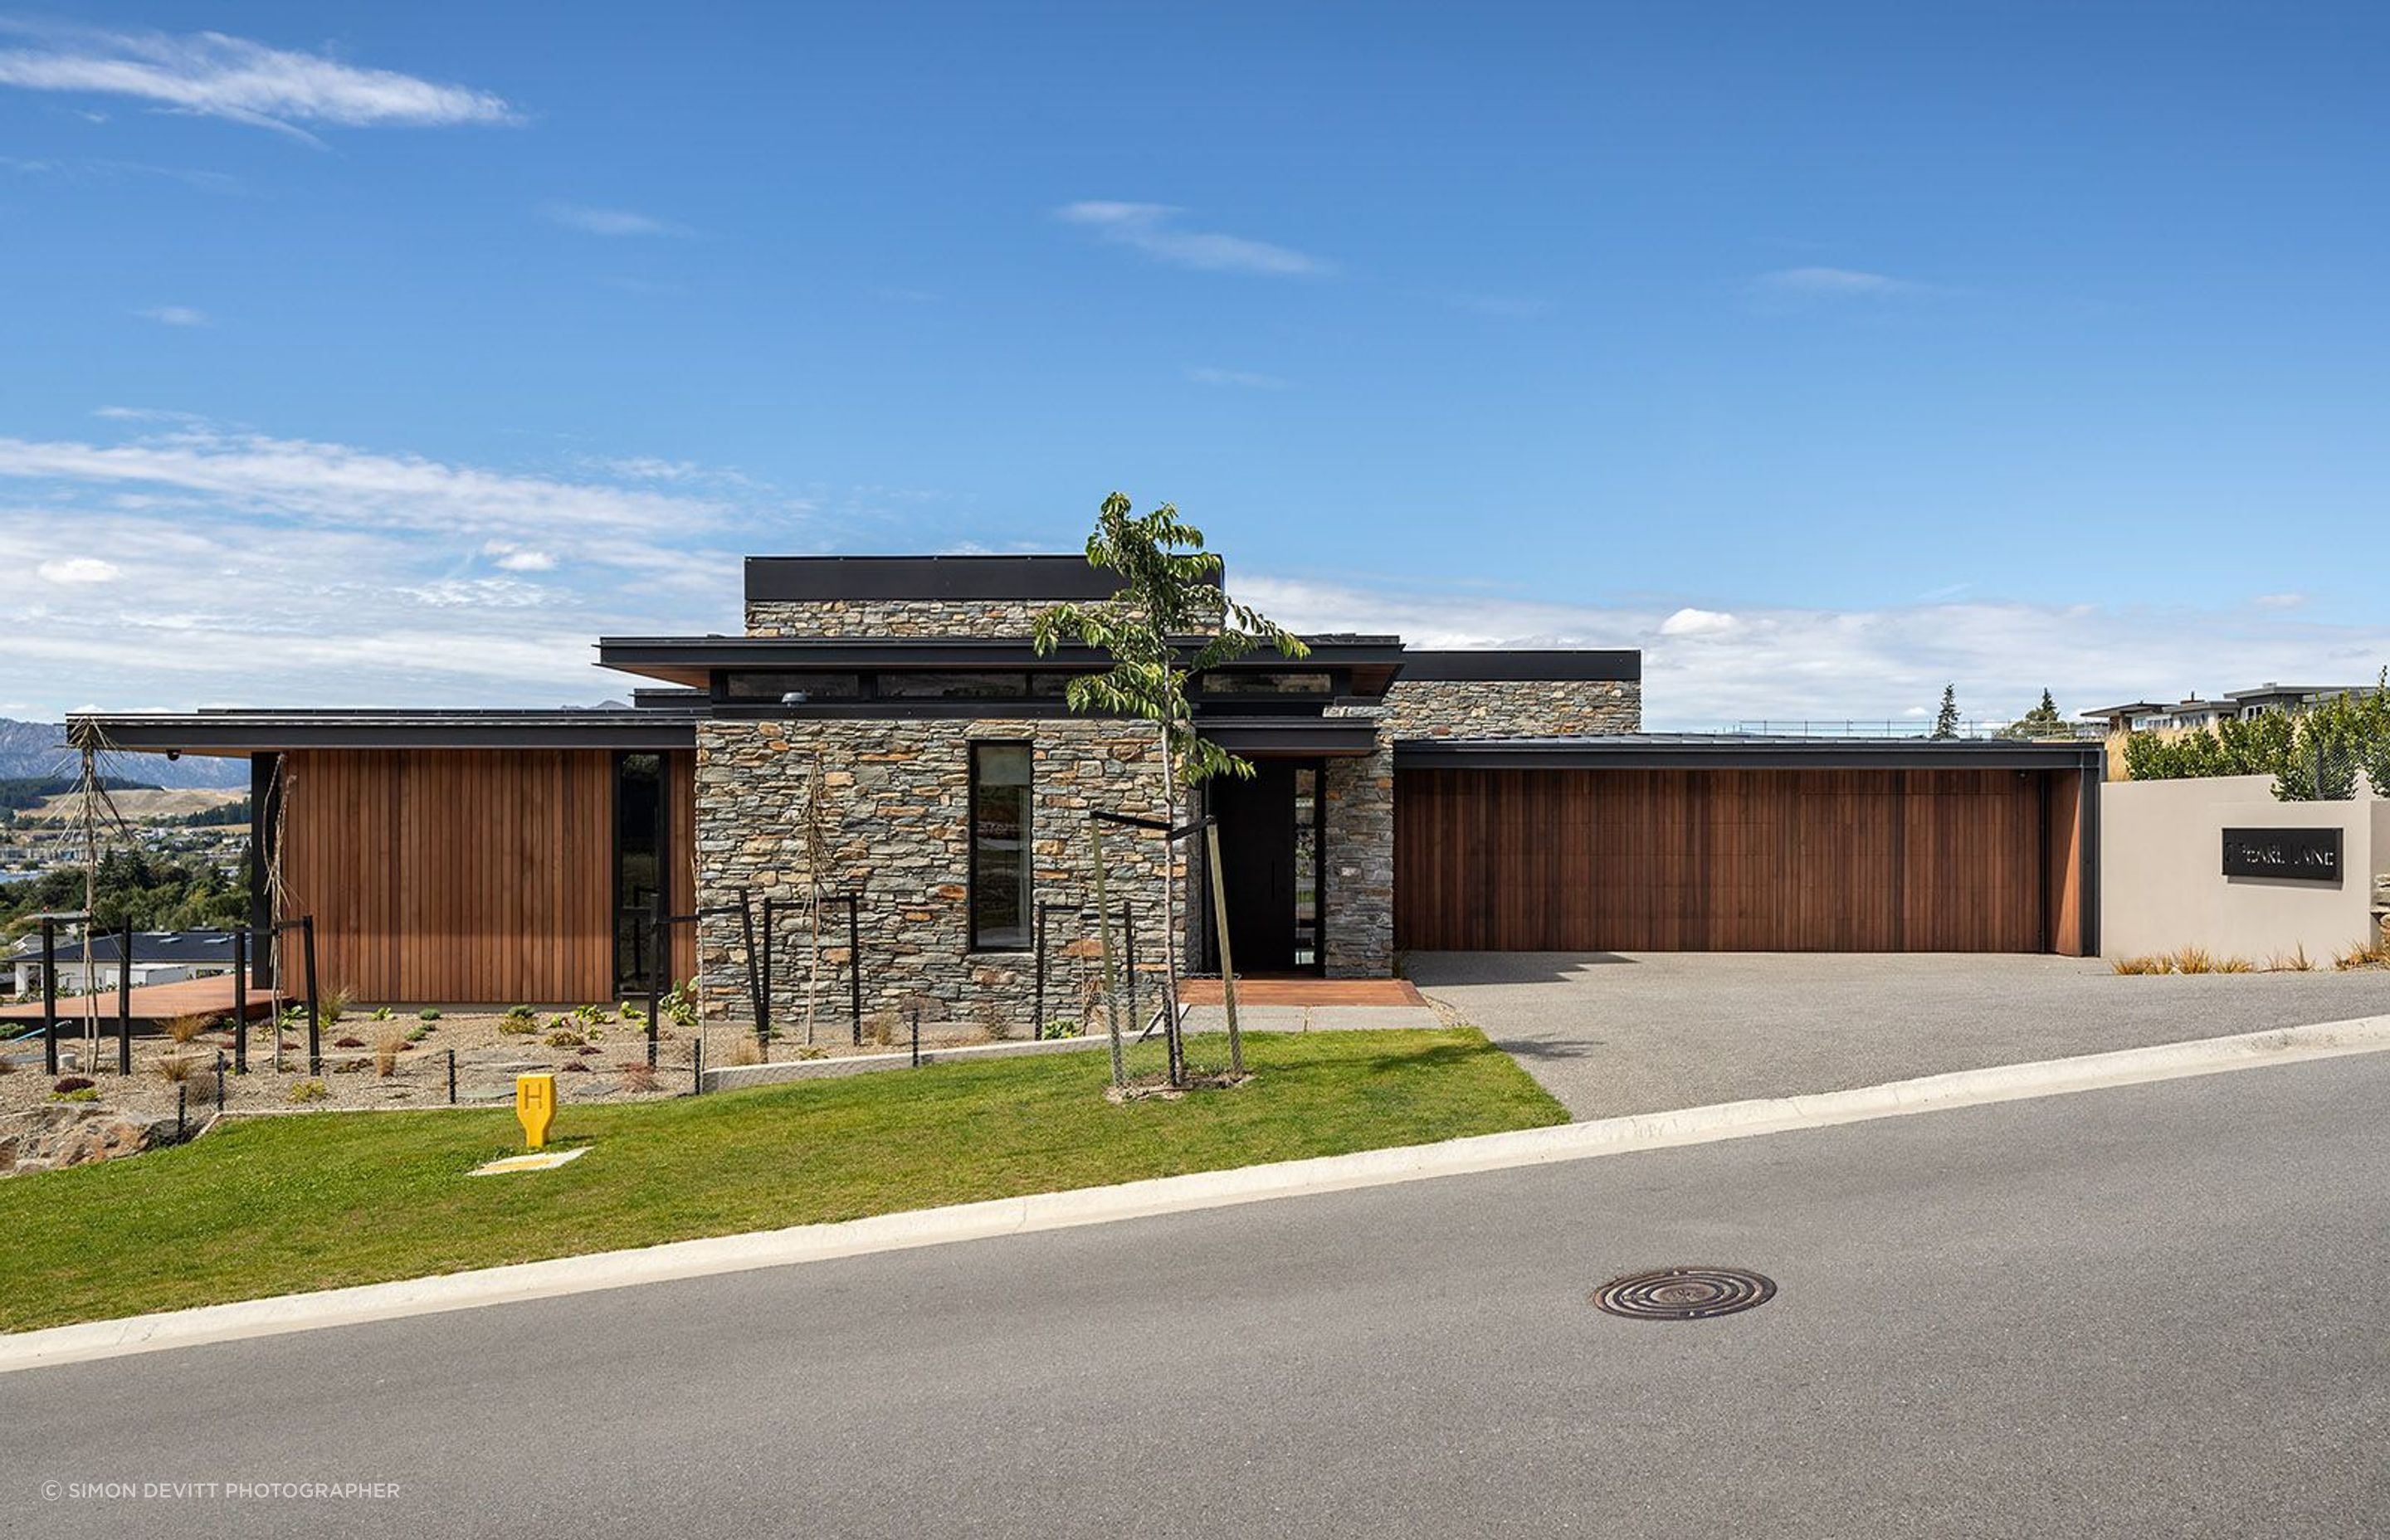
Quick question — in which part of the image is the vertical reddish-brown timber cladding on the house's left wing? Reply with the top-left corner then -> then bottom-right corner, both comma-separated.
280,748 -> 695,1004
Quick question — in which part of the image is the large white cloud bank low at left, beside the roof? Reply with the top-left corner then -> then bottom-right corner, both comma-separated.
0,409 -> 793,713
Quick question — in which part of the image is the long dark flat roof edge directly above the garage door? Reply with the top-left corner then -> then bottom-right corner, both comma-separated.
1393,734 -> 2108,772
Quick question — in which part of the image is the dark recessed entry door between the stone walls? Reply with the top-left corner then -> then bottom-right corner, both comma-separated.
1207,760 -> 1319,973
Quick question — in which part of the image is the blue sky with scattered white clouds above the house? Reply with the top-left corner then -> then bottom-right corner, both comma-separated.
0,2 -> 2390,727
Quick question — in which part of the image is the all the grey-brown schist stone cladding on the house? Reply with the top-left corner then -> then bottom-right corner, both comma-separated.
695,583 -> 1642,1018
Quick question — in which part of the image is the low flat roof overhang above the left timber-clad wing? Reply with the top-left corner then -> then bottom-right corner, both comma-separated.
67,705 -> 698,756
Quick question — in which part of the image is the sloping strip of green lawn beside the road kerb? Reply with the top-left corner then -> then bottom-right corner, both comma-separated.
0,1028 -> 1568,1332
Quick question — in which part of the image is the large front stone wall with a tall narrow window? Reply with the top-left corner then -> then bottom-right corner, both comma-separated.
698,718 -> 1204,1038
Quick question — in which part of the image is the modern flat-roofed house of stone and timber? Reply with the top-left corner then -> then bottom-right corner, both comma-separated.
75,558 -> 2101,1026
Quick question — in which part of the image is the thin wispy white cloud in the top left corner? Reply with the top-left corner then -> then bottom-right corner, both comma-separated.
0,22 -> 519,141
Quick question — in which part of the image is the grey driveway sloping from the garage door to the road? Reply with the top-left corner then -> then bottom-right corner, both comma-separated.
1407,952 -> 2390,1119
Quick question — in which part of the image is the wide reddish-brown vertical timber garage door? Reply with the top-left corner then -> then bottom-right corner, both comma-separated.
1396,768 -> 2075,952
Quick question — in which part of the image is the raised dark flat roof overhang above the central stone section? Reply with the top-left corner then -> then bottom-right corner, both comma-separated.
598,636 -> 1403,699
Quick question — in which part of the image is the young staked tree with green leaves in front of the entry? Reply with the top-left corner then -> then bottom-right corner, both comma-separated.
1035,493 -> 1310,1080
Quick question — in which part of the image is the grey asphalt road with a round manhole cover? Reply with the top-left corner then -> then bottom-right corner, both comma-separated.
0,1055 -> 2390,1540
